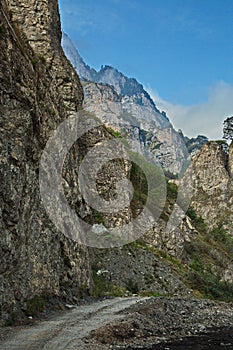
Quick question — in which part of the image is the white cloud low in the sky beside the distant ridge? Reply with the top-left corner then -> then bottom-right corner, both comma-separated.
148,81 -> 233,139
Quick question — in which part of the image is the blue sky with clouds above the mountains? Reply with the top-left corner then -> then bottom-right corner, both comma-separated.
59,0 -> 233,139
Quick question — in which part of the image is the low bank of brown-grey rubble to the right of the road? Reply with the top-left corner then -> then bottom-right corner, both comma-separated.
90,298 -> 233,350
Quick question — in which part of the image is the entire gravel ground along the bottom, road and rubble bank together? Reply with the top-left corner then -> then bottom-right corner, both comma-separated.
0,297 -> 233,350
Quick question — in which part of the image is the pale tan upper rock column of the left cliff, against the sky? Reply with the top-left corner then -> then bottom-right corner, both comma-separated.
6,0 -> 83,111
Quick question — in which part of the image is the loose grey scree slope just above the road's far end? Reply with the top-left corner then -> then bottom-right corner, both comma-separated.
90,244 -> 189,296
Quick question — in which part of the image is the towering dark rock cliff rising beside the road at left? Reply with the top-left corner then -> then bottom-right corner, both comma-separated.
0,0 -> 91,320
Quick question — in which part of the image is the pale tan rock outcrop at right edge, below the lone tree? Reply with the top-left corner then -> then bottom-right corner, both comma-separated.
183,142 -> 233,234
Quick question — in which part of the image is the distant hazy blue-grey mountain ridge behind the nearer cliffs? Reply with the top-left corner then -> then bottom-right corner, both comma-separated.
63,35 -> 188,173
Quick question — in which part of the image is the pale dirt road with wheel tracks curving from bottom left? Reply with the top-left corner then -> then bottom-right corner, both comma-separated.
0,297 -> 147,350
